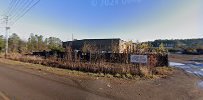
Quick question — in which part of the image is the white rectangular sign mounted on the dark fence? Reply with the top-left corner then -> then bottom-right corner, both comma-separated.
130,55 -> 147,63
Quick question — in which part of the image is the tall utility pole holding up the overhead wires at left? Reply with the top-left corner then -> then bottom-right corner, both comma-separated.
5,16 -> 10,58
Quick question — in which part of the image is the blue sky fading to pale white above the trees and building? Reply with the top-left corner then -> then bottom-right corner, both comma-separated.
0,0 -> 203,41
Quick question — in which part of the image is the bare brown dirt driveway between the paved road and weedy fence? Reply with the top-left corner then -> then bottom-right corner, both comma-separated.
77,70 -> 203,100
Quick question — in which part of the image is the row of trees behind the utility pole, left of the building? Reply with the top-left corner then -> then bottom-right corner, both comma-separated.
0,33 -> 63,53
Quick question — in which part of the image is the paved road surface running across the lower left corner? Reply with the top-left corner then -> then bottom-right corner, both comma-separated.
0,63 -> 110,100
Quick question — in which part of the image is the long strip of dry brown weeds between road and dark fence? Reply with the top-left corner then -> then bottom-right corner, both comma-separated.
0,54 -> 172,79
